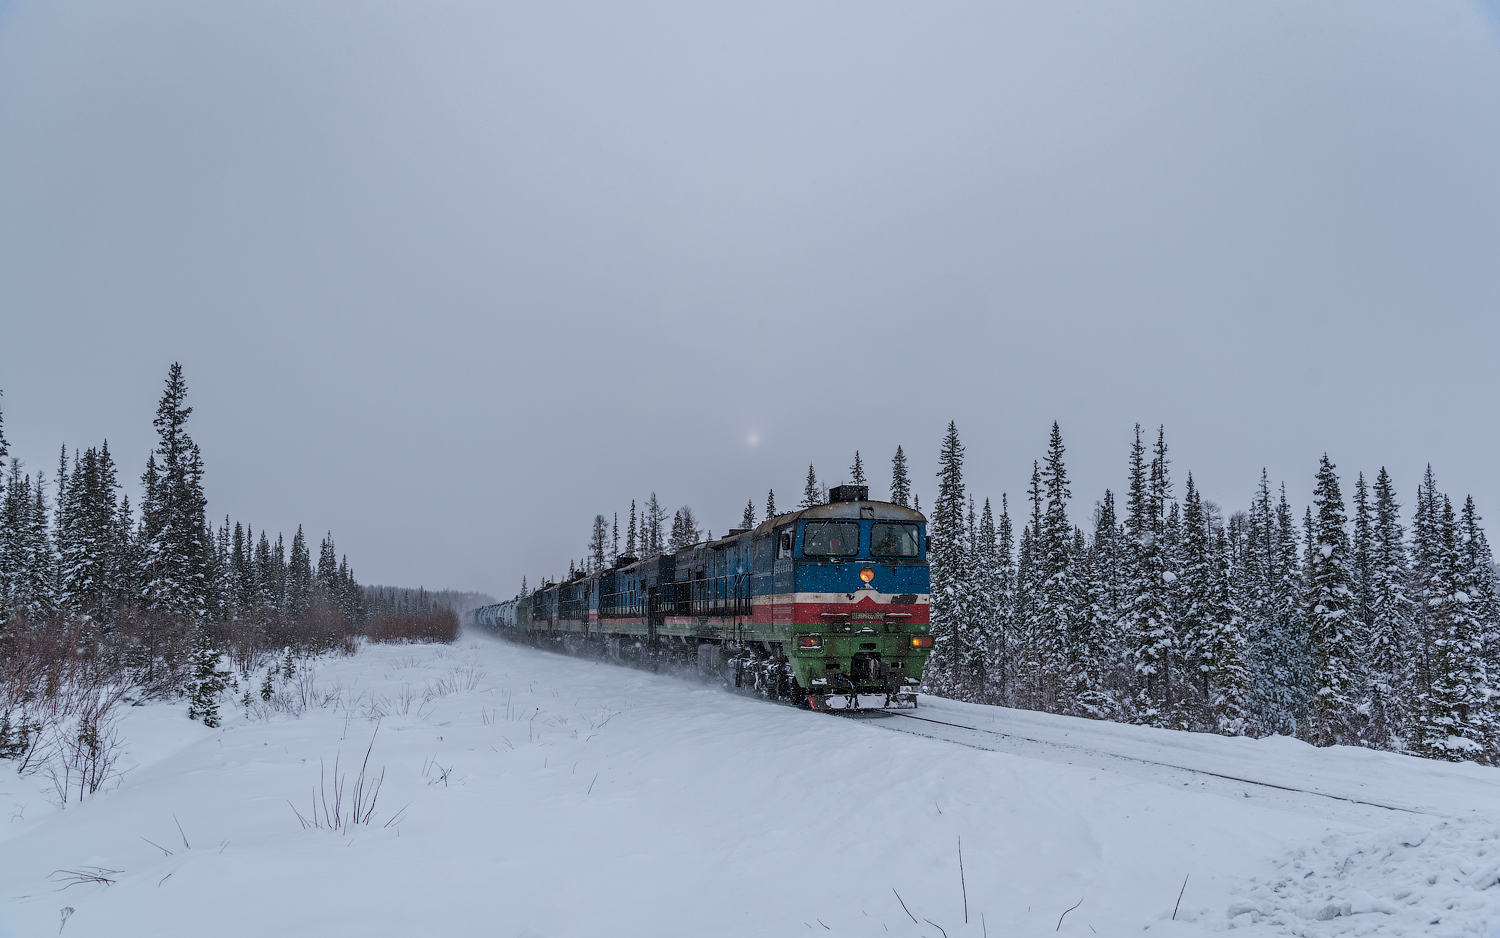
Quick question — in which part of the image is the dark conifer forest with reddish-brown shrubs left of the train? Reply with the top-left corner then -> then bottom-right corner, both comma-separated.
0,365 -> 468,774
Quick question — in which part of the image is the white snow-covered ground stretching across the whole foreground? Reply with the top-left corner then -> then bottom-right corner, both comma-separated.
0,635 -> 1500,938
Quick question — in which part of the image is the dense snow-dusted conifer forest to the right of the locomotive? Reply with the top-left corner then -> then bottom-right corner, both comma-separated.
896,425 -> 1500,764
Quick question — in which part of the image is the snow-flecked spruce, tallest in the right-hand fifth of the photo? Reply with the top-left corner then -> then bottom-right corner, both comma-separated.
1304,455 -> 1365,746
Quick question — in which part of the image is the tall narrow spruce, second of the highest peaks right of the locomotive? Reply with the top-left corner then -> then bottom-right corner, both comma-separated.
1035,422 -> 1079,713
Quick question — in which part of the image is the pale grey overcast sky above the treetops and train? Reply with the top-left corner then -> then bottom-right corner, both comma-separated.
0,0 -> 1500,596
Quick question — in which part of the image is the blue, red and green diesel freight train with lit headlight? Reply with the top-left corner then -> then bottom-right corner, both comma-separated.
474,485 -> 933,710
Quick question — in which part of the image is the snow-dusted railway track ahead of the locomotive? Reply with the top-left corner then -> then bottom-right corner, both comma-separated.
848,710 -> 1454,818
